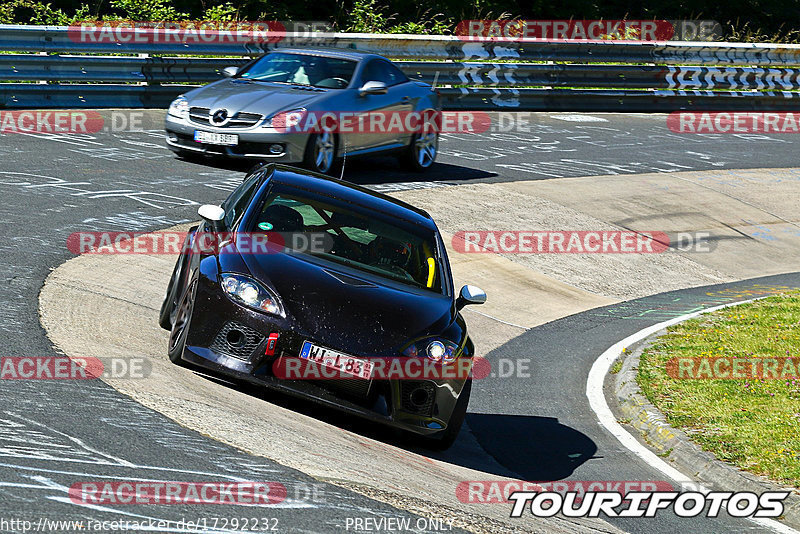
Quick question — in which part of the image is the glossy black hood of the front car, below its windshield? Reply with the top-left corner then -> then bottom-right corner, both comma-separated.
221,248 -> 455,356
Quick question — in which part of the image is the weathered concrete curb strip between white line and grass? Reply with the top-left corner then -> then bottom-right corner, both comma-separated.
610,329 -> 800,529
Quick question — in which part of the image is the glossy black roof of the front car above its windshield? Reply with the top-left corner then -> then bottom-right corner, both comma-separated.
267,164 -> 436,231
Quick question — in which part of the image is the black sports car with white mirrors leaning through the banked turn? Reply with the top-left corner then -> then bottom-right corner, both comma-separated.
160,165 -> 486,447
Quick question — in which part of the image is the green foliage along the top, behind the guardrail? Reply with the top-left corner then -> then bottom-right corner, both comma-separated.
0,0 -> 800,42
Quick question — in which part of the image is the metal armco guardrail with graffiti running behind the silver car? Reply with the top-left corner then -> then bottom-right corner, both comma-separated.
0,25 -> 800,111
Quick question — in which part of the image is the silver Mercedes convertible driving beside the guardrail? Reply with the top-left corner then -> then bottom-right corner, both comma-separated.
166,50 -> 441,174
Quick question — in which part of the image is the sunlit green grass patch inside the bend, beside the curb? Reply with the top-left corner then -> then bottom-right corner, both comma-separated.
637,292 -> 800,487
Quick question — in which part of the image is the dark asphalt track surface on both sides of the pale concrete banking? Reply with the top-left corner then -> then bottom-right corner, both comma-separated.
0,111 -> 800,533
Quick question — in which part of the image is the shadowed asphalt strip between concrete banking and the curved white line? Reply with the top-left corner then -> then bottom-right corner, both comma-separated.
476,273 -> 800,533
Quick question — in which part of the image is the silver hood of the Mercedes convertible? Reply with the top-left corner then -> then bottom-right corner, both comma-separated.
186,80 -> 327,115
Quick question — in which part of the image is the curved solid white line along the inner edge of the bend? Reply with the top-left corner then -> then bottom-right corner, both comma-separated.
586,297 -> 800,534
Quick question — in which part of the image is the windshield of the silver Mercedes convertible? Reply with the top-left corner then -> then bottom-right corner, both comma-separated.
236,52 -> 356,89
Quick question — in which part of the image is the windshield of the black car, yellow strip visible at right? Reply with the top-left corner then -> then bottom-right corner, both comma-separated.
251,191 -> 442,293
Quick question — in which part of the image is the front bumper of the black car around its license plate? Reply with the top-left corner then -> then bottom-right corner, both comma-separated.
183,276 -> 465,435
